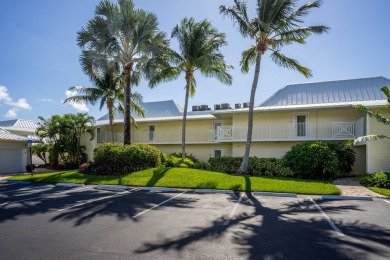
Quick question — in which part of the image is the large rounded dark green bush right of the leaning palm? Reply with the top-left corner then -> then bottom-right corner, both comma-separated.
282,141 -> 355,179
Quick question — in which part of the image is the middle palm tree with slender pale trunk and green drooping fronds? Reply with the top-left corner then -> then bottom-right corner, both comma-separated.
158,18 -> 232,159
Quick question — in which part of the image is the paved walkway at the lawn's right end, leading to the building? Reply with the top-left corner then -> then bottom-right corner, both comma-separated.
333,177 -> 387,198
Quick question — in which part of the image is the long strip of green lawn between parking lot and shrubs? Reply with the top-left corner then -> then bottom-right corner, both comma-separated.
10,168 -> 340,195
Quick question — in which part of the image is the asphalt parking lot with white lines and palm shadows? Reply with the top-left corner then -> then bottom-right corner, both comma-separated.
0,183 -> 390,259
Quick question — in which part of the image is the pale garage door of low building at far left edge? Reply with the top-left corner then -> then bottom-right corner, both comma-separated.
0,149 -> 26,173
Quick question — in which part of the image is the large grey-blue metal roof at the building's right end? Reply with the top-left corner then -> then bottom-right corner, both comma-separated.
259,77 -> 390,107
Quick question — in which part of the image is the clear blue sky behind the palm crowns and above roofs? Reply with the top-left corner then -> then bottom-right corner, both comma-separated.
0,0 -> 390,120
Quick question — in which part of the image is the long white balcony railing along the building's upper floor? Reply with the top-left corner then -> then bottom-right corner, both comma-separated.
98,121 -> 364,144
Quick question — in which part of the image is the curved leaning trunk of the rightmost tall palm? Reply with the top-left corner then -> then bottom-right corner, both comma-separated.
237,53 -> 261,174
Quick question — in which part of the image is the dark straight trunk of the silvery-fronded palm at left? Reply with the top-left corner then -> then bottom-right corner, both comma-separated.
123,63 -> 132,145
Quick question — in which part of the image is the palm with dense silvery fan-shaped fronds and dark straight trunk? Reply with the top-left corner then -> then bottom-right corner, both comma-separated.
77,0 -> 169,144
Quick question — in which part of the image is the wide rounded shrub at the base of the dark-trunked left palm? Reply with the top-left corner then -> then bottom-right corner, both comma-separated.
91,143 -> 163,175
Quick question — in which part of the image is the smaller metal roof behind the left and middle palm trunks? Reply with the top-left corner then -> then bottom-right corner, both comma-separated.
97,100 -> 213,121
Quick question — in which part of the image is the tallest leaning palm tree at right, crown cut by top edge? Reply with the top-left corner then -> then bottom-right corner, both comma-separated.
219,0 -> 329,174
